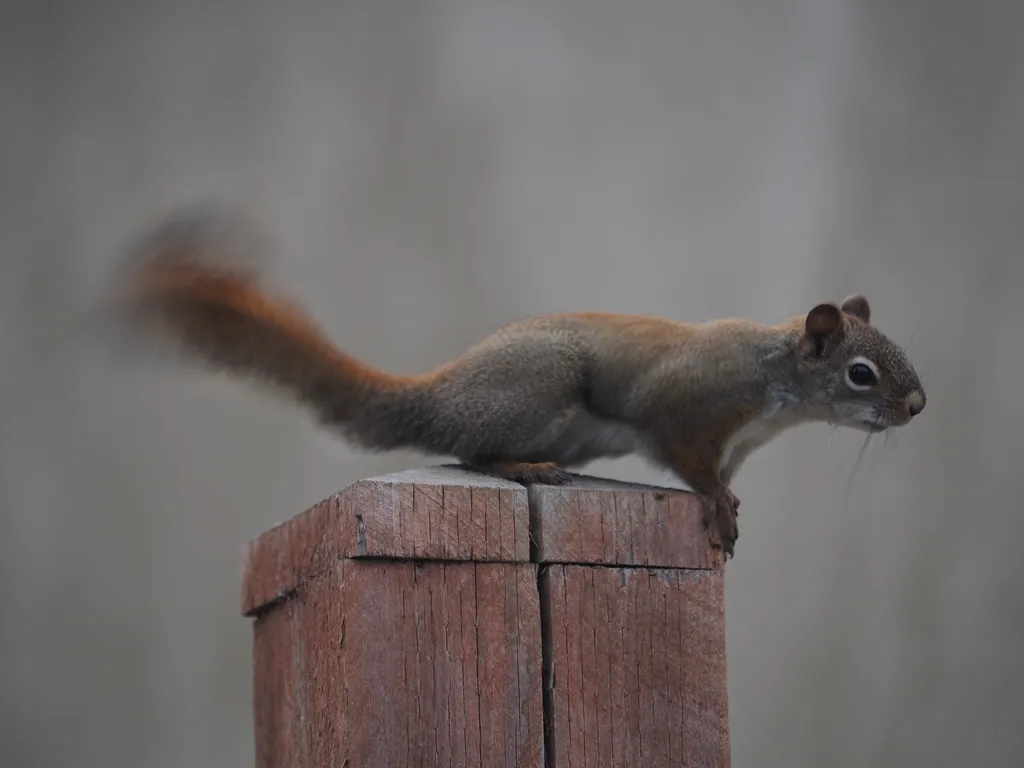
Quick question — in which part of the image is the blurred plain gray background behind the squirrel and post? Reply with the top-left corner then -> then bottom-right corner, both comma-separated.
0,0 -> 1024,768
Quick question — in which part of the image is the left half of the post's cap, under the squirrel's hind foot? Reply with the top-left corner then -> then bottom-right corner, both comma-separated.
242,467 -> 529,615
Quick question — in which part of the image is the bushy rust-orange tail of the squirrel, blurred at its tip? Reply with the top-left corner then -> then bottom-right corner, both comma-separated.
107,205 -> 421,449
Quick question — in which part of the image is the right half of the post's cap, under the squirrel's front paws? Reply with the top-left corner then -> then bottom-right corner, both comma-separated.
529,477 -> 722,568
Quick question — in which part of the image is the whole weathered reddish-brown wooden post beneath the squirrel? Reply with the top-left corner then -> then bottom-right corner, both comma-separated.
243,467 -> 729,768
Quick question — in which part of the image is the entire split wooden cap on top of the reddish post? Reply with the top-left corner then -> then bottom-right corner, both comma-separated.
243,465 -> 721,614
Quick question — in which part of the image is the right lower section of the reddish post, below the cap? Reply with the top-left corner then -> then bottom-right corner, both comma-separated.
541,565 -> 729,768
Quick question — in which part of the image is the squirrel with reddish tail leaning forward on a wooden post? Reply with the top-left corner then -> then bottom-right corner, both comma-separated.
105,209 -> 925,559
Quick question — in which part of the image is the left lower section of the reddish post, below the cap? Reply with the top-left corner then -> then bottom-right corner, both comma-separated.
248,559 -> 544,768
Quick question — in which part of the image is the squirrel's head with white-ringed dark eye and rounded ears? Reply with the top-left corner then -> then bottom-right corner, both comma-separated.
798,295 -> 925,432
